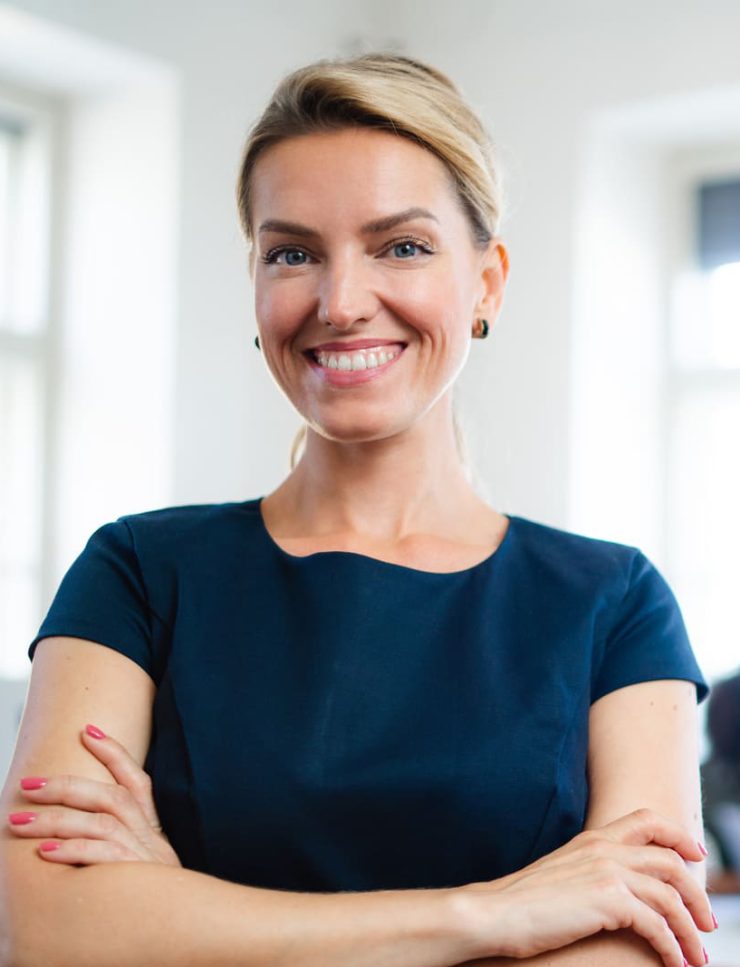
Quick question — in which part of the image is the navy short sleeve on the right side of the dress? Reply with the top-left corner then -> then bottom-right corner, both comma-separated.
591,550 -> 709,703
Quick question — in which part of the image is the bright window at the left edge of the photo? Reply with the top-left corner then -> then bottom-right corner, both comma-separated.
0,88 -> 53,679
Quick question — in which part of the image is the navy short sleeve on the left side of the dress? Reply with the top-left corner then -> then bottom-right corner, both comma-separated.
28,519 -> 156,680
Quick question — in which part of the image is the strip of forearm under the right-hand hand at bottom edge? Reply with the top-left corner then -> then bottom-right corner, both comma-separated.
458,930 -> 663,967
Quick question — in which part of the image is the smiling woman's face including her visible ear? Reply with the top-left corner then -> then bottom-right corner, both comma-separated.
252,128 -> 507,442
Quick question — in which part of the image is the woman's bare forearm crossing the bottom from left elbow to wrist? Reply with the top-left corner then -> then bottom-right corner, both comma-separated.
1,855 -> 470,967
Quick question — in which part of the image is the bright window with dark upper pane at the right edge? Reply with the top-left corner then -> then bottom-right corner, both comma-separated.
666,161 -> 740,679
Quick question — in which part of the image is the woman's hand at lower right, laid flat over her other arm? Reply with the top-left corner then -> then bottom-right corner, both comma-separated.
458,809 -> 716,967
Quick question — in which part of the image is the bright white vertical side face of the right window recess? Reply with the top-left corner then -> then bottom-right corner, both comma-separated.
569,135 -> 665,555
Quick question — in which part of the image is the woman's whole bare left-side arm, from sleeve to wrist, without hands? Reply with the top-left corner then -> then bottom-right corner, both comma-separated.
0,638 -> 470,967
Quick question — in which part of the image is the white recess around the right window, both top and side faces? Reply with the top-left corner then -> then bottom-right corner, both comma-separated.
569,96 -> 740,568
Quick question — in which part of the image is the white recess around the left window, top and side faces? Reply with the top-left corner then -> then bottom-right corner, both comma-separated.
0,6 -> 179,588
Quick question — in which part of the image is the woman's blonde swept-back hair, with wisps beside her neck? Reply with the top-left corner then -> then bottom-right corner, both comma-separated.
236,52 -> 502,476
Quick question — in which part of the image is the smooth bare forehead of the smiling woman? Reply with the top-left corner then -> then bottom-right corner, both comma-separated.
252,128 -> 458,224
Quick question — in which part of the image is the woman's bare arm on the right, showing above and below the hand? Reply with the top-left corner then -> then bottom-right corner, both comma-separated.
450,680 -> 706,967
